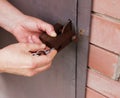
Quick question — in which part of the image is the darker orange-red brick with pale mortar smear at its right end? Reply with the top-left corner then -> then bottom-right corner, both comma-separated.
88,45 -> 118,78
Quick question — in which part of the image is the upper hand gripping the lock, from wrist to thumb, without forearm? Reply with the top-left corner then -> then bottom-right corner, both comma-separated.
12,15 -> 56,43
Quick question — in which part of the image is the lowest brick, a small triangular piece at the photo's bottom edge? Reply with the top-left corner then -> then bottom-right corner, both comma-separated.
86,88 -> 107,98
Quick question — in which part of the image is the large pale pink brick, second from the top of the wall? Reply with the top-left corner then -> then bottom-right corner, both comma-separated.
90,15 -> 120,54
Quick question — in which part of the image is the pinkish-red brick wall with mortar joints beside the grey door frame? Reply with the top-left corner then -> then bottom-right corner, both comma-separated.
86,0 -> 120,98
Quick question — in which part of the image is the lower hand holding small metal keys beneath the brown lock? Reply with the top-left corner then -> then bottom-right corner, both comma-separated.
0,43 -> 57,77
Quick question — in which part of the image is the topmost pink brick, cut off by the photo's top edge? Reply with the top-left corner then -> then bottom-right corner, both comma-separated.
93,0 -> 120,19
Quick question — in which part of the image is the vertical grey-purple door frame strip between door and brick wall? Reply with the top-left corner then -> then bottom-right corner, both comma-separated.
76,0 -> 92,98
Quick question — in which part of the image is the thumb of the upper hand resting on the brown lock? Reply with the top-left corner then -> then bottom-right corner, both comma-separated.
39,22 -> 57,37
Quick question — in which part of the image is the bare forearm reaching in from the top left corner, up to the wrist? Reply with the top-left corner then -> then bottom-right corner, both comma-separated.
0,0 -> 24,32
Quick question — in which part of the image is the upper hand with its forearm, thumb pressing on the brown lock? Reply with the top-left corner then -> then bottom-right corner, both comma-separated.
0,0 -> 56,43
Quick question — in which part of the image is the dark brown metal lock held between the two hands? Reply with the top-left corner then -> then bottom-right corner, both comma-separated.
39,20 -> 77,52
